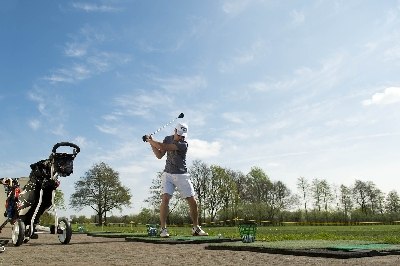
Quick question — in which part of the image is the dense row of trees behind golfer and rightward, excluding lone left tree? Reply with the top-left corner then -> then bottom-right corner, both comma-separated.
147,160 -> 400,223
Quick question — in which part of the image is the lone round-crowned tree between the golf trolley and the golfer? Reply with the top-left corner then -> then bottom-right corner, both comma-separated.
70,162 -> 132,224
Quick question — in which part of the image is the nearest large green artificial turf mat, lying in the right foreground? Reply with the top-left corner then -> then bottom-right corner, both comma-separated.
205,240 -> 400,259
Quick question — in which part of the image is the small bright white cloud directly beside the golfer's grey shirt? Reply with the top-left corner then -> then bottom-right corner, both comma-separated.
188,139 -> 222,159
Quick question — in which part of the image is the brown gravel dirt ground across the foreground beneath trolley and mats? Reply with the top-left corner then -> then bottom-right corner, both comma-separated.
0,228 -> 400,266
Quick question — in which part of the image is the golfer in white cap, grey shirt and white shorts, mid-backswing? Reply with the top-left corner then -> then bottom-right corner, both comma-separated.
146,123 -> 208,237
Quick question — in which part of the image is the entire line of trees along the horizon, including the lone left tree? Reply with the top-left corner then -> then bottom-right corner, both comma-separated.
65,160 -> 400,224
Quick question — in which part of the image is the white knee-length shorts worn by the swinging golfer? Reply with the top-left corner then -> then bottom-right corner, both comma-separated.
161,172 -> 195,199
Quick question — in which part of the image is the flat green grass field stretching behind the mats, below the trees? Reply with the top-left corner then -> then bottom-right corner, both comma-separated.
73,224 -> 400,244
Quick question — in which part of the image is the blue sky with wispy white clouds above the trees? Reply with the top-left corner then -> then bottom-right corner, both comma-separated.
0,0 -> 400,218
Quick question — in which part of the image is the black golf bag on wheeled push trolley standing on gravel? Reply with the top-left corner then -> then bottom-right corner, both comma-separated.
0,142 -> 80,246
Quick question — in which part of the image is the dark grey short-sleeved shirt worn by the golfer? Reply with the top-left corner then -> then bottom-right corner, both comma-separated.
163,135 -> 188,174
